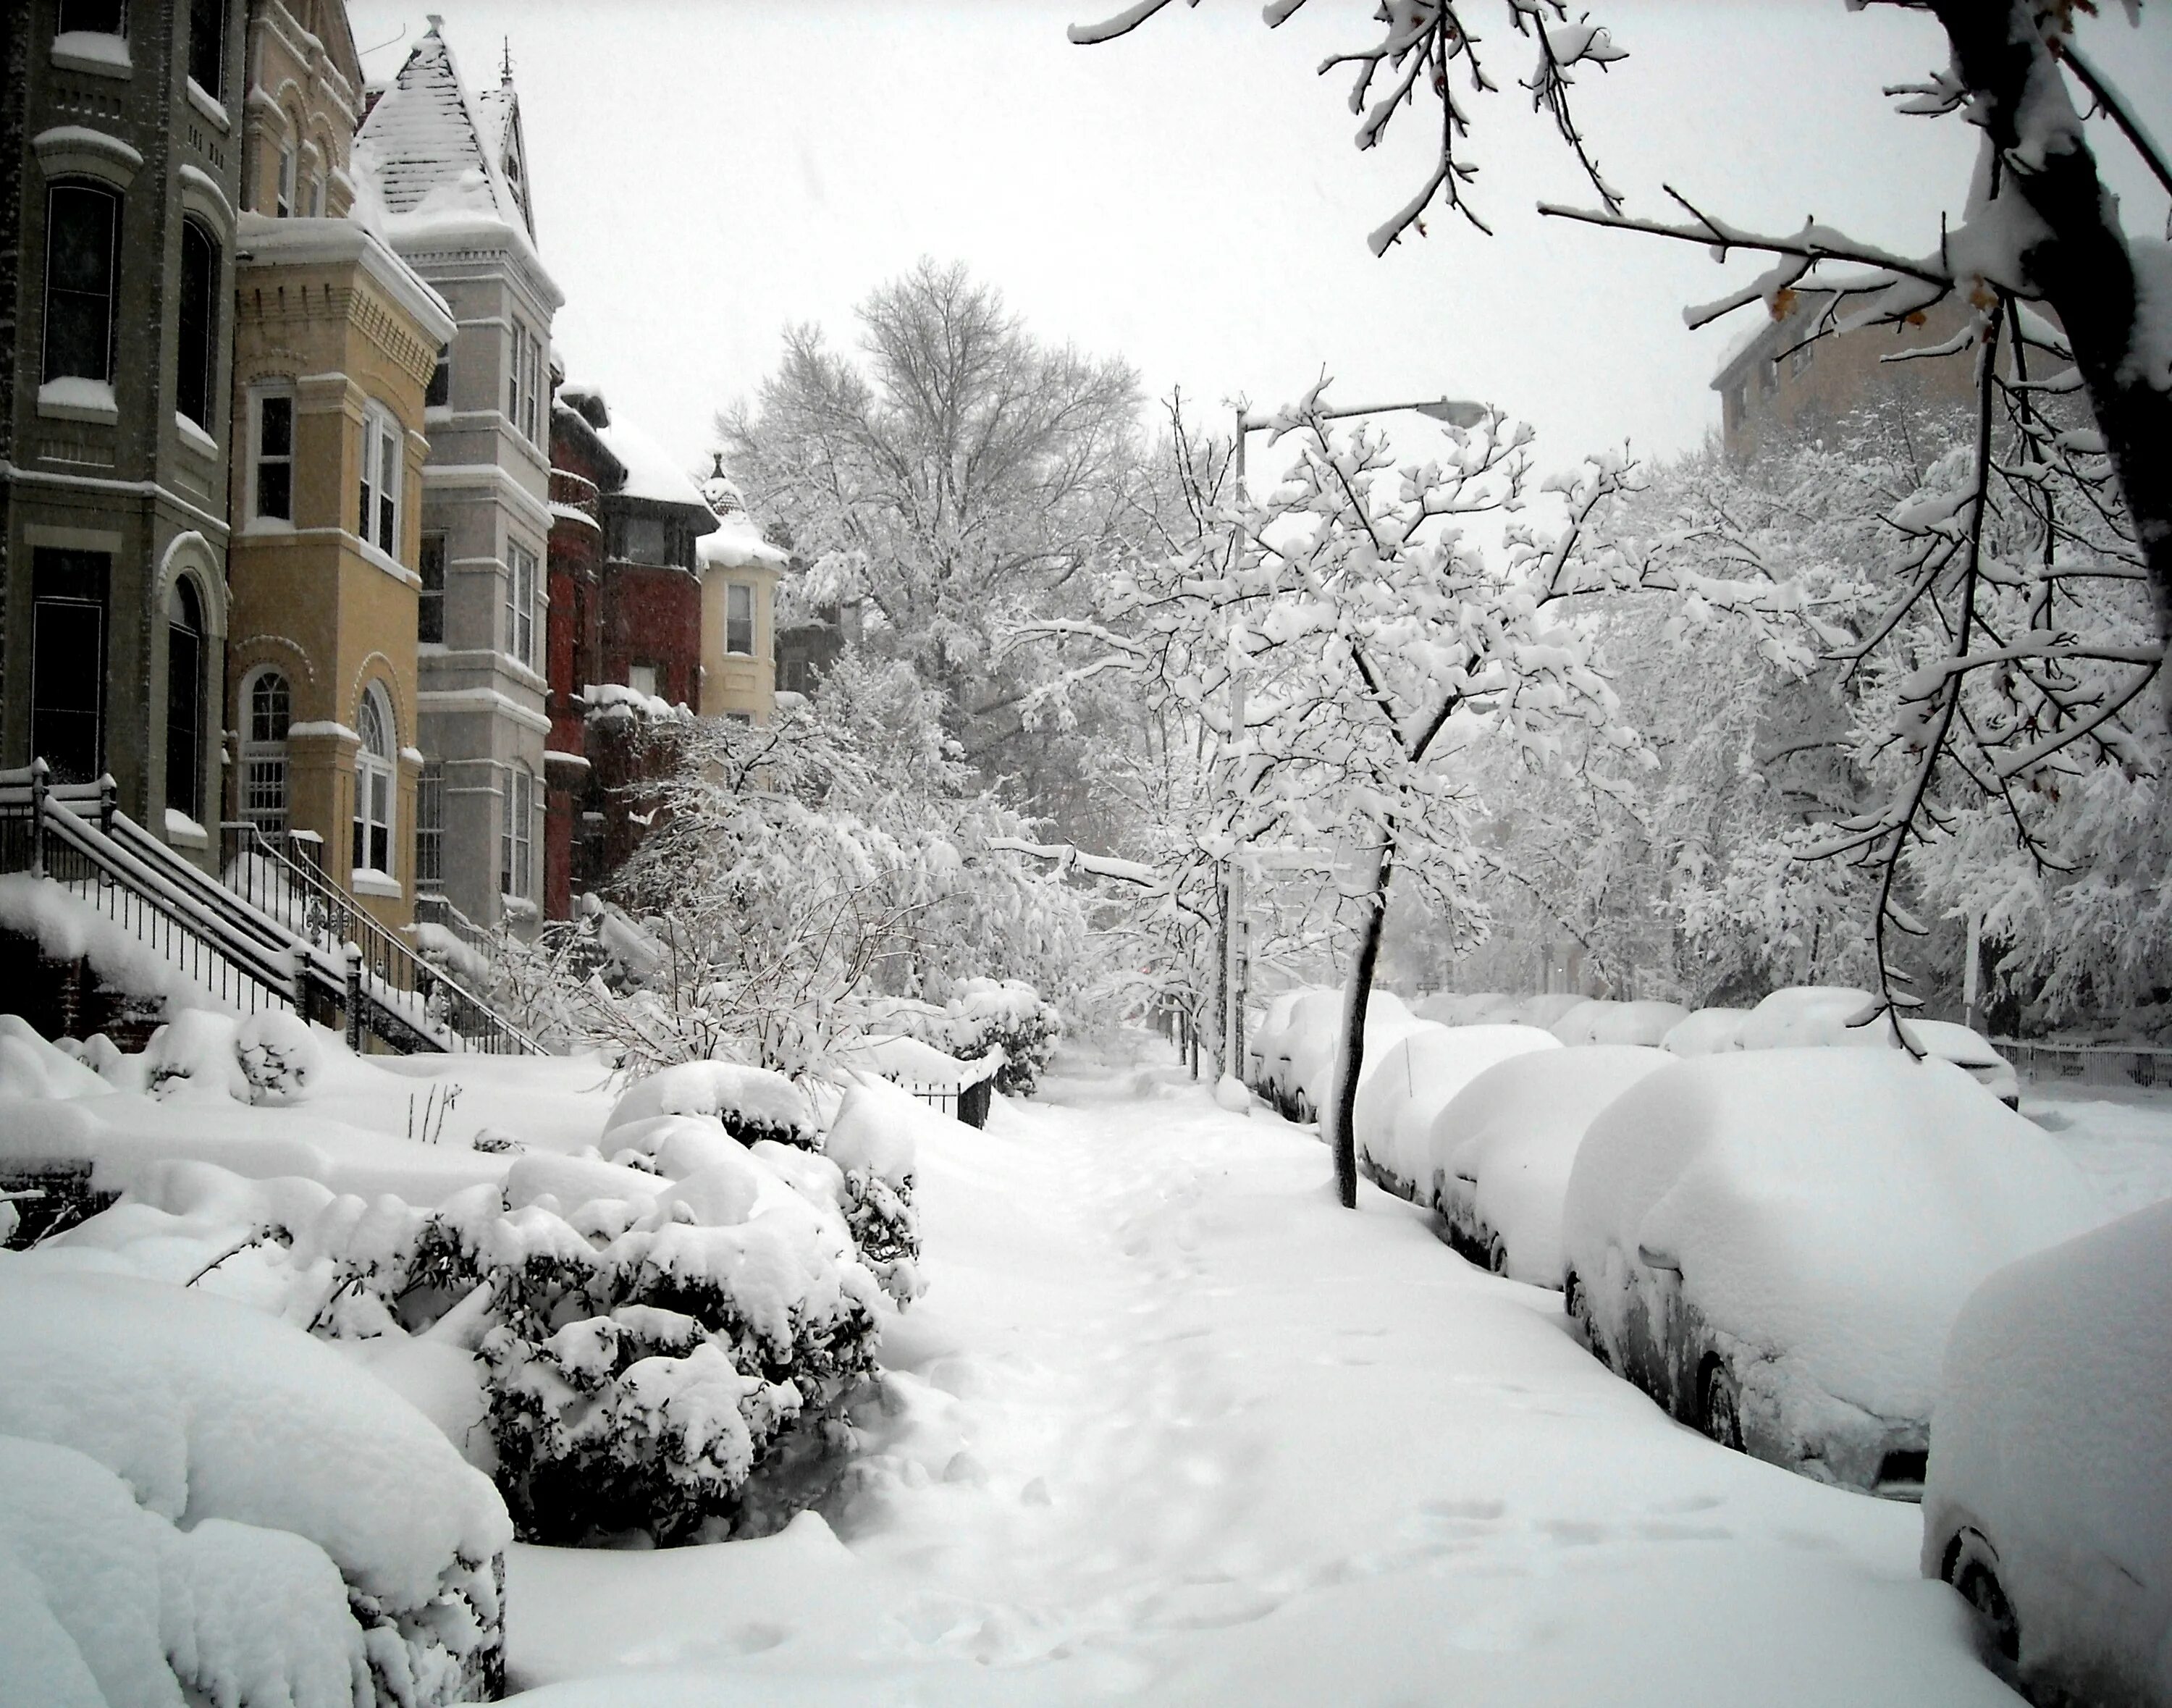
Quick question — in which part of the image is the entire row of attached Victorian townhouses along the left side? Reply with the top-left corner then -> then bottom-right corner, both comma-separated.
0,0 -> 786,956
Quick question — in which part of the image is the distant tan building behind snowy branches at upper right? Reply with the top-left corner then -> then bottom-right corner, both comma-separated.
1712,291 -> 1977,463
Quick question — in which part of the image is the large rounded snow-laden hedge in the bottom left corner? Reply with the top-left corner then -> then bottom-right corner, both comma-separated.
0,1252 -> 513,1704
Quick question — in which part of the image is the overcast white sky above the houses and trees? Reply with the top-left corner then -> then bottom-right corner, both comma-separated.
348,0 -> 2172,478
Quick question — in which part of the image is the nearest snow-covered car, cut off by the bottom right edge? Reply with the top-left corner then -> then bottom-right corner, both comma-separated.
1922,1202 -> 2172,1708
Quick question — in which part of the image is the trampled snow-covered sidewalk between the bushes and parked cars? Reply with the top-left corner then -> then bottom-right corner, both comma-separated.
508,1043 -> 2016,1708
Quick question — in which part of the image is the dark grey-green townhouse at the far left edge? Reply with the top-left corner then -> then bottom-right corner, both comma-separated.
0,0 -> 243,863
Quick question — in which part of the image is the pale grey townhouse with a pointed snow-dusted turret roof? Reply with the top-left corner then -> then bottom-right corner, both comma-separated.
354,17 -> 563,926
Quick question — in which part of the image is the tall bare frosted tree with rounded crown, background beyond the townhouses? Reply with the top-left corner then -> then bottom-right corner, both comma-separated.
717,261 -> 1140,791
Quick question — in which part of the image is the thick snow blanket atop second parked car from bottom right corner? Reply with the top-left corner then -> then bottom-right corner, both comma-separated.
1562,1050 -> 2102,1417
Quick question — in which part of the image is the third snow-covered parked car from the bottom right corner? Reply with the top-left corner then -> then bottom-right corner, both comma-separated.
1431,1043 -> 1672,1287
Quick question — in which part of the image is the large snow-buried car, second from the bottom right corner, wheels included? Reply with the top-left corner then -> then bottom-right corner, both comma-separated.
1562,1050 -> 2102,1495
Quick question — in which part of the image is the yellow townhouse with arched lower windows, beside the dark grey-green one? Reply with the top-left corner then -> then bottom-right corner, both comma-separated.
226,0 -> 454,926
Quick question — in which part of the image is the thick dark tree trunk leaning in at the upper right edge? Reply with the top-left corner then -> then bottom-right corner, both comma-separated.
1933,0 -> 2172,699
